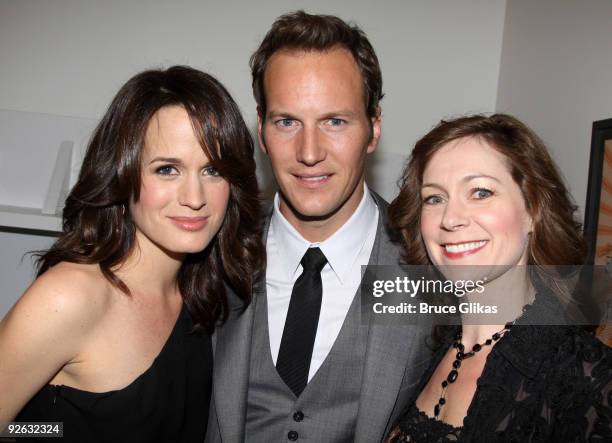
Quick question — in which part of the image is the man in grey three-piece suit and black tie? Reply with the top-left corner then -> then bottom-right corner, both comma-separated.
207,11 -> 428,443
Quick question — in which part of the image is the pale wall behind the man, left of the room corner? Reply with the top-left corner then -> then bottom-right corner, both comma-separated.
0,0 -> 506,316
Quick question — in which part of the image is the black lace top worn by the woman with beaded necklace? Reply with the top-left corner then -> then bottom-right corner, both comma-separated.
392,294 -> 612,443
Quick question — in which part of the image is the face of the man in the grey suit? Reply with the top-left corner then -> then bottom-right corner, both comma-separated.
258,48 -> 380,240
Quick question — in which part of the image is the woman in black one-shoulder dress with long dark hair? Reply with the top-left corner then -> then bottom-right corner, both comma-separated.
0,66 -> 263,442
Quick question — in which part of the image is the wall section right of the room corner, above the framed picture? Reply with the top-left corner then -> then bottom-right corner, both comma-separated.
497,0 -> 612,217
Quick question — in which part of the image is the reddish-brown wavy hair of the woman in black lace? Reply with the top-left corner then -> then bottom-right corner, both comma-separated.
389,114 -> 586,266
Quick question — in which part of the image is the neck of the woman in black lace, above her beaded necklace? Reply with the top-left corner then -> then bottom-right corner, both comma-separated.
460,266 -> 535,349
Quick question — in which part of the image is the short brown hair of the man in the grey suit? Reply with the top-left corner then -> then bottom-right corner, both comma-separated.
249,11 -> 383,118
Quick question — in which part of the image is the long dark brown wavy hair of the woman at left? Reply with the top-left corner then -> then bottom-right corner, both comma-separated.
37,66 -> 265,331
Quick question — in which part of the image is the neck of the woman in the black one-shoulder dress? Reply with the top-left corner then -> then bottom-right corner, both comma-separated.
114,231 -> 185,297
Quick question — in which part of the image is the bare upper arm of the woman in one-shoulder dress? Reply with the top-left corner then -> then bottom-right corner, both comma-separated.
0,264 -> 99,423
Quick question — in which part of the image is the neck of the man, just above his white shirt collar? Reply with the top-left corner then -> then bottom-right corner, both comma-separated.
279,178 -> 365,243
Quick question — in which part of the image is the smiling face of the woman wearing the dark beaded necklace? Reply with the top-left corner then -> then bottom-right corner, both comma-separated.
421,137 -> 532,267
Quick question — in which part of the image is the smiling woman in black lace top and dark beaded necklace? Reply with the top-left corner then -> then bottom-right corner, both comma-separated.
388,114 -> 612,442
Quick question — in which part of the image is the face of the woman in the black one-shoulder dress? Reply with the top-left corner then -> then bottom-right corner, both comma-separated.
130,106 -> 230,254
